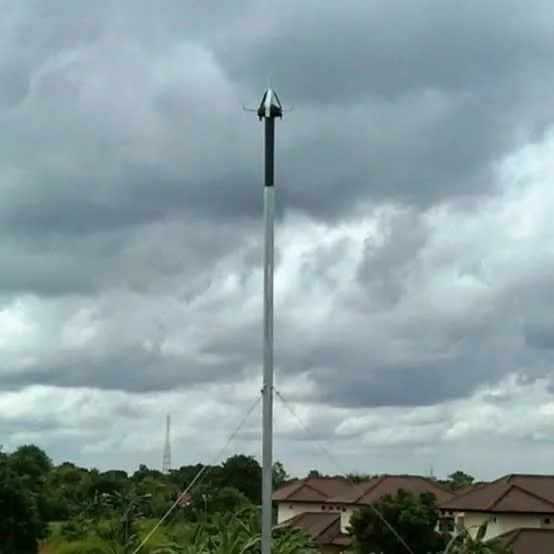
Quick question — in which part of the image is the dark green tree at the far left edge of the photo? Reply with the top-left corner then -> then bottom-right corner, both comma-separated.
0,458 -> 45,554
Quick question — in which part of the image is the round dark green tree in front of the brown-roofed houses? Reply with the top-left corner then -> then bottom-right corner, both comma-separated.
350,490 -> 446,554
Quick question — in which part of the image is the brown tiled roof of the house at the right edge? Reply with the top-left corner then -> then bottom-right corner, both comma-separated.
440,474 -> 554,514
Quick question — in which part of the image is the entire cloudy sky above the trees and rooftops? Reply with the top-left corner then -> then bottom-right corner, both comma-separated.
0,0 -> 554,478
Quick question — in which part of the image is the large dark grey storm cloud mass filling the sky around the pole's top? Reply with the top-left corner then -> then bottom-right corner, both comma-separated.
0,1 -> 550,253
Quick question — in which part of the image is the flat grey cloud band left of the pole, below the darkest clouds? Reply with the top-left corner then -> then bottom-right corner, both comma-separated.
0,216 -> 254,299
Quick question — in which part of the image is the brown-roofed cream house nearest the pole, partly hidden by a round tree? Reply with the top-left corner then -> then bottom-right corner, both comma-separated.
274,475 -> 454,553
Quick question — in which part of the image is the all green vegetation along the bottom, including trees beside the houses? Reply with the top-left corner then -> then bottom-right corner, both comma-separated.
0,445 -> 495,554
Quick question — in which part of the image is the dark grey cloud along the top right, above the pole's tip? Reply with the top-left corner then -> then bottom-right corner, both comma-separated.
212,0 -> 552,105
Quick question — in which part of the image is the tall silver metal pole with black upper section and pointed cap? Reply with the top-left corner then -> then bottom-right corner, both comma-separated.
257,85 -> 283,554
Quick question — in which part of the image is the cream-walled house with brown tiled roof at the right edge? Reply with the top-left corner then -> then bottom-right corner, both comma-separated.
439,474 -> 554,540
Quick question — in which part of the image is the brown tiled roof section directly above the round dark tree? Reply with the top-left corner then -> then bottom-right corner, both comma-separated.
326,475 -> 455,504
